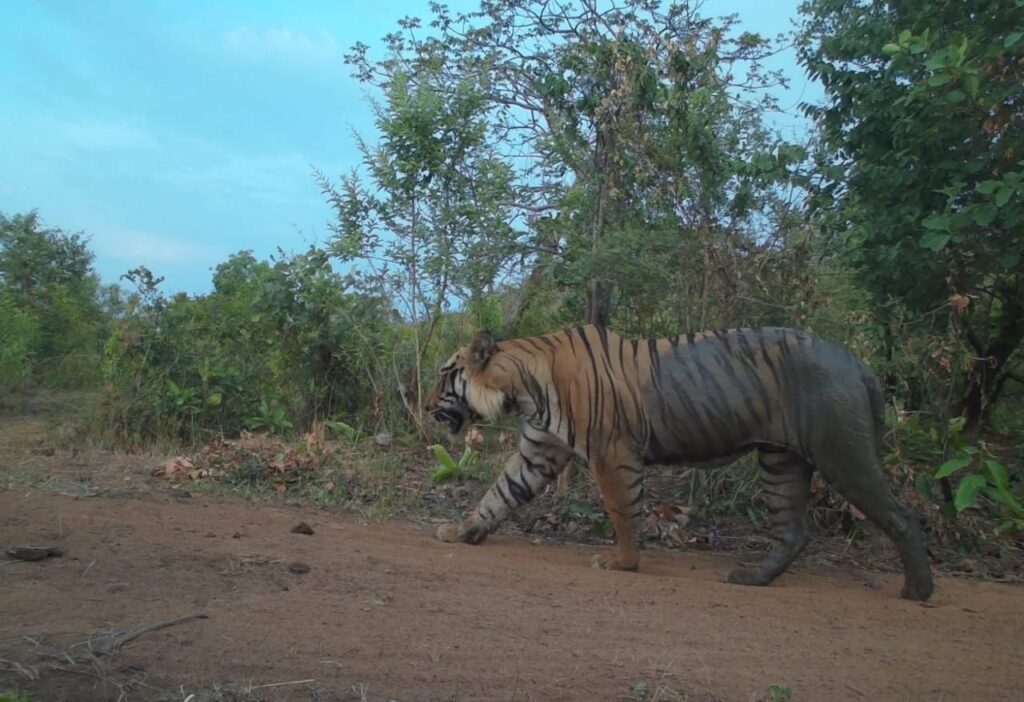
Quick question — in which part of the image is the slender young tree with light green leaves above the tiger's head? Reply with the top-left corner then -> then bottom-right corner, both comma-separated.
318,57 -> 518,423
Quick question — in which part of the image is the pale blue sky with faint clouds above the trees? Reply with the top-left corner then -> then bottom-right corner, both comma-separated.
0,0 -> 819,294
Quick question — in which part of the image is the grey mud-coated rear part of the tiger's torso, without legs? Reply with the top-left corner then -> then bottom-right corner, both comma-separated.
642,327 -> 874,464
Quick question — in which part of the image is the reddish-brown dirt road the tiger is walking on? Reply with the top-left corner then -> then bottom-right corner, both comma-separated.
0,491 -> 1024,700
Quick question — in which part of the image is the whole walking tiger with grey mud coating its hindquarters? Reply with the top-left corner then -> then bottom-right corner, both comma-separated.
424,325 -> 934,602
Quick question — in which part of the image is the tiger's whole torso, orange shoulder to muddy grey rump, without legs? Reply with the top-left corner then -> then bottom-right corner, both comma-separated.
540,326 -> 878,472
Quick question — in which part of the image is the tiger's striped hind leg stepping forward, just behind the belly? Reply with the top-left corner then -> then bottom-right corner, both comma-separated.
728,450 -> 814,585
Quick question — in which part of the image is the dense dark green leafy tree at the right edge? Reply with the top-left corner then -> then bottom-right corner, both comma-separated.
799,0 -> 1024,425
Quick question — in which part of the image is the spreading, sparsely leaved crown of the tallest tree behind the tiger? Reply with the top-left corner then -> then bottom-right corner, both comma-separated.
348,0 -> 799,324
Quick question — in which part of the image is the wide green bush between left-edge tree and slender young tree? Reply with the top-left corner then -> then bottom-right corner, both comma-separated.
98,250 -> 395,443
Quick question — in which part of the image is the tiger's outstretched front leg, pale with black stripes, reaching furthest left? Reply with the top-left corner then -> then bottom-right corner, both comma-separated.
437,434 -> 571,544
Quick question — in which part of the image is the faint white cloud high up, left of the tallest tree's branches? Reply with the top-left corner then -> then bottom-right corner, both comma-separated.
222,27 -> 342,65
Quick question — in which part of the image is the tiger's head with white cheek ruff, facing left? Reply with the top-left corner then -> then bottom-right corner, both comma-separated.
423,332 -> 506,444
